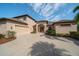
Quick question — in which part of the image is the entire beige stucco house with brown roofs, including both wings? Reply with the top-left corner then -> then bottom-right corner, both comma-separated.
0,15 -> 77,35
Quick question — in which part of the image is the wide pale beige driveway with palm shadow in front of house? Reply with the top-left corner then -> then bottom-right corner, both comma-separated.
0,34 -> 79,56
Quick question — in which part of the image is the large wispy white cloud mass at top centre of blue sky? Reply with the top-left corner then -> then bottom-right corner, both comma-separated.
30,3 -> 65,19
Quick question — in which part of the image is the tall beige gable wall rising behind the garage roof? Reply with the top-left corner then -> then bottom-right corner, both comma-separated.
14,16 -> 36,34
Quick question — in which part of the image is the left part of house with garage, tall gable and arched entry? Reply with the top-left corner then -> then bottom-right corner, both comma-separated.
0,15 -> 48,35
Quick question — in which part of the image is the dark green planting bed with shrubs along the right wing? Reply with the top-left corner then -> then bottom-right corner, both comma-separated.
45,28 -> 79,40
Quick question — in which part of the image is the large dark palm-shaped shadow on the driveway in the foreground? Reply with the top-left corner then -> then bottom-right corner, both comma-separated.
28,41 -> 70,56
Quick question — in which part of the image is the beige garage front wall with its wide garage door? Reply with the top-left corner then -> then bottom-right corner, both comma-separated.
6,21 -> 28,35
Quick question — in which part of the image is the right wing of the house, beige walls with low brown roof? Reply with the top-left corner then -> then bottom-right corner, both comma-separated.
52,20 -> 77,34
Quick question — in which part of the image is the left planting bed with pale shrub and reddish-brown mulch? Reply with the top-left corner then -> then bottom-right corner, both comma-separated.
0,31 -> 16,44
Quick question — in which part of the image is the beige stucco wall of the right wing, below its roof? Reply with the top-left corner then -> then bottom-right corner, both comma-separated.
55,24 -> 77,34
